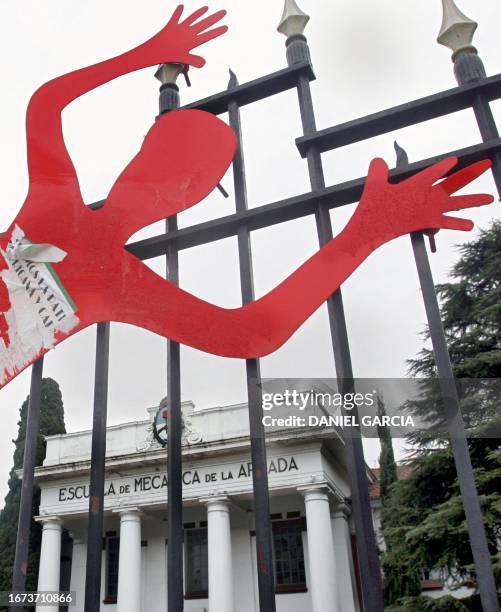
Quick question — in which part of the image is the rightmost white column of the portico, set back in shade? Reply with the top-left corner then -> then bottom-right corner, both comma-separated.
332,504 -> 360,612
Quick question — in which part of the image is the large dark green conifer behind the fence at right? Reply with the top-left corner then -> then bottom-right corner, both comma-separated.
383,222 -> 501,612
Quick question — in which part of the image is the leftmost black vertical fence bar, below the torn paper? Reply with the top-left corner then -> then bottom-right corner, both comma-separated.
12,357 -> 43,591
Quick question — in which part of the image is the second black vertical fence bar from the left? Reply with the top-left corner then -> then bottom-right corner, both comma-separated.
85,323 -> 110,612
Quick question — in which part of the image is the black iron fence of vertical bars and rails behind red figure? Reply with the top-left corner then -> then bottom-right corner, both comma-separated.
9,1 -> 501,612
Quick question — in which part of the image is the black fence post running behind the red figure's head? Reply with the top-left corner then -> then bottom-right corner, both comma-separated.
160,73 -> 184,612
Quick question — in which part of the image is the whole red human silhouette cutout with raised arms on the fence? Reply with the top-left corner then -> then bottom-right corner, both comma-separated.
0,7 -> 493,385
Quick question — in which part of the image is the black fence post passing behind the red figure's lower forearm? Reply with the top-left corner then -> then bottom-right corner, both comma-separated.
286,34 -> 384,612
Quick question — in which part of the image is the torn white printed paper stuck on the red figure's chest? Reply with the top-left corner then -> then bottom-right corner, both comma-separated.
0,225 -> 79,384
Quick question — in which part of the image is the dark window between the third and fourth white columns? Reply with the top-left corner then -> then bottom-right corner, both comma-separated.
272,519 -> 306,593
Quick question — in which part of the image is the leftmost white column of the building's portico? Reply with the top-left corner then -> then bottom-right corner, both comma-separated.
35,516 -> 63,612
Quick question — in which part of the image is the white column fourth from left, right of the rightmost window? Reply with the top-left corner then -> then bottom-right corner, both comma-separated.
301,487 -> 339,612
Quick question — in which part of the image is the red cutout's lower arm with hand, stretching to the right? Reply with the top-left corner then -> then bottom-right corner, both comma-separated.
107,158 -> 493,358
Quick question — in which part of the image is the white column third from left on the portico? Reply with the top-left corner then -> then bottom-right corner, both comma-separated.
202,497 -> 233,612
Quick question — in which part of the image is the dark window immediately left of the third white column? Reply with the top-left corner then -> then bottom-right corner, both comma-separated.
185,528 -> 209,599
